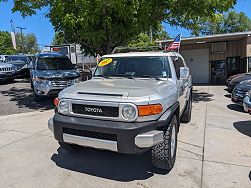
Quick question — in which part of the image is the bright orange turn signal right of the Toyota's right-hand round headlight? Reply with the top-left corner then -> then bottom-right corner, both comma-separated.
137,104 -> 163,116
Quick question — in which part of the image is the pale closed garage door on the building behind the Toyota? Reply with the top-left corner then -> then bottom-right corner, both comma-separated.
180,49 -> 209,83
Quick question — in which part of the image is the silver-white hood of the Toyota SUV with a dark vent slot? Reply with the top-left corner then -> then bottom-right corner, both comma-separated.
59,78 -> 175,100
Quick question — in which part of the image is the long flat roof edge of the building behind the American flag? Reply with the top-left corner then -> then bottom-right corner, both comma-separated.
156,31 -> 251,44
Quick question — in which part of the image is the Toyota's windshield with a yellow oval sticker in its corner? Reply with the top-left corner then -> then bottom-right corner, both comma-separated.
94,56 -> 171,78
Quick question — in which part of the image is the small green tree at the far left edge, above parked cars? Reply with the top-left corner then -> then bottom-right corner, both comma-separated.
0,31 -> 16,55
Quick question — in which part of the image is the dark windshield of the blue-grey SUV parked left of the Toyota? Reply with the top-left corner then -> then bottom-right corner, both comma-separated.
37,57 -> 73,70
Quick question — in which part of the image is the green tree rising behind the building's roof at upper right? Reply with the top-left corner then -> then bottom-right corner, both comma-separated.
193,10 -> 251,35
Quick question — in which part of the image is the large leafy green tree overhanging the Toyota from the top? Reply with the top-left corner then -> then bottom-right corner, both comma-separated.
0,0 -> 237,54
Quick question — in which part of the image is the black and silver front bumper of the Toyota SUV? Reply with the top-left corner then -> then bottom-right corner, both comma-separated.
48,114 -> 169,153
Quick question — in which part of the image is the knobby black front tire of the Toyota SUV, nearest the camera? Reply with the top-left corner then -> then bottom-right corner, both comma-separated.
152,115 -> 178,171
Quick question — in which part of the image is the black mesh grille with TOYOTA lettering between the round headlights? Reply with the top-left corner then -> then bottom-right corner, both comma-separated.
72,104 -> 119,117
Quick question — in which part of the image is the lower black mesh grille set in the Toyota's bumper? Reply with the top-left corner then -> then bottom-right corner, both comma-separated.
63,127 -> 117,141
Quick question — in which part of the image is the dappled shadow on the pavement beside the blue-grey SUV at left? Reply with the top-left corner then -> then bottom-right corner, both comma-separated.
0,87 -> 54,110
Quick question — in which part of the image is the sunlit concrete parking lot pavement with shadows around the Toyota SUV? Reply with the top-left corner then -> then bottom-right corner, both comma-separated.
0,84 -> 251,188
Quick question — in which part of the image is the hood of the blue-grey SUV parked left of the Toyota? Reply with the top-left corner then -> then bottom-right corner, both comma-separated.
34,70 -> 80,78
